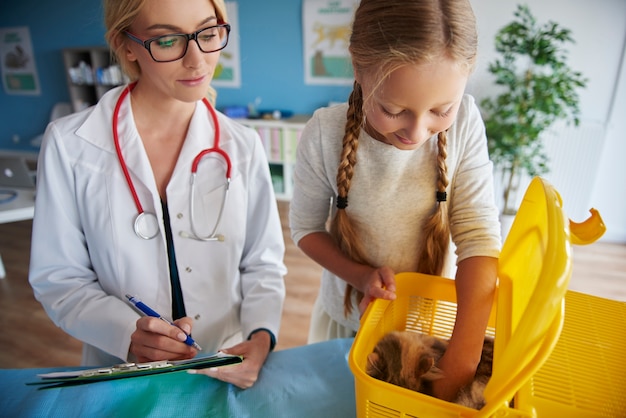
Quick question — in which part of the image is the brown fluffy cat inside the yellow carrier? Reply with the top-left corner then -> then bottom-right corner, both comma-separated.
366,331 -> 493,409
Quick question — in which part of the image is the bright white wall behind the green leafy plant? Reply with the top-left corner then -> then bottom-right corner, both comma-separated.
468,0 -> 626,243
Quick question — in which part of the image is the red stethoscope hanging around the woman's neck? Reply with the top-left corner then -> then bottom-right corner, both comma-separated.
113,82 -> 231,241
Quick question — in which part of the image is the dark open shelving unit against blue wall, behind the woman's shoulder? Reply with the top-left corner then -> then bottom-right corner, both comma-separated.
63,46 -> 127,112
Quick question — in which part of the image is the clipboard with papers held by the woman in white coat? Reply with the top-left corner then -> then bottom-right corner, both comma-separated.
26,352 -> 243,387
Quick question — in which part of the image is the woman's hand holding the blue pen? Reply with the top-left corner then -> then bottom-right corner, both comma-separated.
129,316 -> 198,363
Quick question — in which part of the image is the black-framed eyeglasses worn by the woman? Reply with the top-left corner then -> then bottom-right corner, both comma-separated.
124,23 -> 230,62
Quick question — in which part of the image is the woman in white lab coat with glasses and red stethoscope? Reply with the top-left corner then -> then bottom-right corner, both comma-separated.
29,0 -> 286,388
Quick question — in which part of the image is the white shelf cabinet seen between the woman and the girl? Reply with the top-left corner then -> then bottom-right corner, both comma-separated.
235,115 -> 309,200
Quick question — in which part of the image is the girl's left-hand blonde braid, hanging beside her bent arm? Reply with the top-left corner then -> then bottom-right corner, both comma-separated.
330,81 -> 369,316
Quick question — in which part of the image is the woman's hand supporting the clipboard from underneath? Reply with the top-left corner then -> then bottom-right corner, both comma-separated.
187,331 -> 271,389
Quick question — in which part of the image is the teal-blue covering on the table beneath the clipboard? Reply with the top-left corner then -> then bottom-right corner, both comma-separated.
0,339 -> 356,418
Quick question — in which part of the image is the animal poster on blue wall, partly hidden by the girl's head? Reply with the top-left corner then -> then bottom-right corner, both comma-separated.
302,0 -> 358,85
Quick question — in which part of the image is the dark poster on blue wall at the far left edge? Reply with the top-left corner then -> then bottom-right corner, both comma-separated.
0,26 -> 40,95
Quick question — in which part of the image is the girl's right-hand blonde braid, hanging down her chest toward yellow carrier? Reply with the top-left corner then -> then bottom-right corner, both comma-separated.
417,132 -> 450,276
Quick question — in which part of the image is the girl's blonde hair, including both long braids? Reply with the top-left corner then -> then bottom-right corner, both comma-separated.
330,0 -> 478,314
